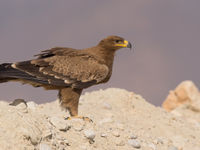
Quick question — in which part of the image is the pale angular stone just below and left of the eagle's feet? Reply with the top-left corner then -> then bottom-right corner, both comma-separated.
49,117 -> 70,131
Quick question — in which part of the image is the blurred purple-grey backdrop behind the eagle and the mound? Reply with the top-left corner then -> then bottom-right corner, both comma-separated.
0,0 -> 200,105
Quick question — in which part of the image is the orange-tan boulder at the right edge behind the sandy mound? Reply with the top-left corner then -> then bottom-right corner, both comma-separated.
162,81 -> 200,111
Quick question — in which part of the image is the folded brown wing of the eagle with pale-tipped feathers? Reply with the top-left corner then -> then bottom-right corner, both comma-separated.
15,48 -> 109,89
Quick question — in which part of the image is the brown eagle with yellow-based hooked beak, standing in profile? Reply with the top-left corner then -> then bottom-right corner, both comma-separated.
0,36 -> 131,116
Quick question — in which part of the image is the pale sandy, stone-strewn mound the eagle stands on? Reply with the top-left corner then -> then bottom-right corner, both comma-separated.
0,88 -> 200,150
